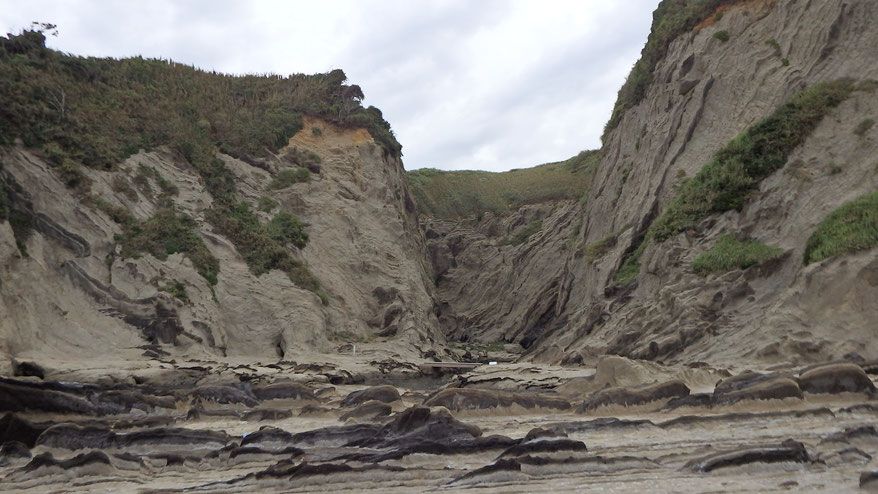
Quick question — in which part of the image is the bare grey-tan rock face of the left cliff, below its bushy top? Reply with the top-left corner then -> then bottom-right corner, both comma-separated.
0,118 -> 444,373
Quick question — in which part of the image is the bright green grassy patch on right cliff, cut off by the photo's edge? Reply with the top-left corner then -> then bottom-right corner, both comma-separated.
804,191 -> 878,264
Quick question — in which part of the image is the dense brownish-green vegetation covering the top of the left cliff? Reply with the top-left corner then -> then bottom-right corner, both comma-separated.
0,31 -> 401,190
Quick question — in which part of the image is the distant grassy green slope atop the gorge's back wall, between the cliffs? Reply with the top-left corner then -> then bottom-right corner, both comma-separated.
407,151 -> 600,218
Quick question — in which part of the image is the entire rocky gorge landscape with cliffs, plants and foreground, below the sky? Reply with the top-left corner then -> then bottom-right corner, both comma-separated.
0,0 -> 878,492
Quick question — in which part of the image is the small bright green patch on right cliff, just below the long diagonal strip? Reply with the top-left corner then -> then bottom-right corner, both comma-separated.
692,234 -> 783,275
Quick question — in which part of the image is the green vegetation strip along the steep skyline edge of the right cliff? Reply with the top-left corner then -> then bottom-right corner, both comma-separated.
603,0 -> 734,141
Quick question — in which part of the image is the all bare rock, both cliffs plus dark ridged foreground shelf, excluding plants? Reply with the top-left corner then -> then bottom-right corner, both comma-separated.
0,0 -> 878,493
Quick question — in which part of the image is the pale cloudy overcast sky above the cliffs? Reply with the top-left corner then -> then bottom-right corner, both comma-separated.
0,0 -> 658,171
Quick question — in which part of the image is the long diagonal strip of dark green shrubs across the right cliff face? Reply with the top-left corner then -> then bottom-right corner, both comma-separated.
650,80 -> 853,241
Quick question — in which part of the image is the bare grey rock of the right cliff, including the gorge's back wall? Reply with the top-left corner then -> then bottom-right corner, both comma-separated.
425,0 -> 878,366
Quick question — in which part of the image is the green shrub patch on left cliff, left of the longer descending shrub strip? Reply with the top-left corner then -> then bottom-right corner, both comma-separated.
117,209 -> 219,285
